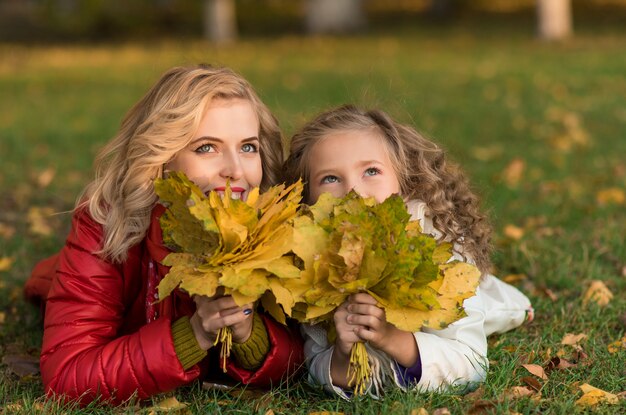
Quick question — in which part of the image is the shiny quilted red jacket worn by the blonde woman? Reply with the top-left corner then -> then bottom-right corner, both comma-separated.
25,206 -> 303,403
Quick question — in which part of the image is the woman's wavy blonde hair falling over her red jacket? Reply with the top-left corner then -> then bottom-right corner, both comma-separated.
76,65 -> 283,263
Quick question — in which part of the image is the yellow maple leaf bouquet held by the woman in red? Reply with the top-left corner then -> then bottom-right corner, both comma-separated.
154,172 -> 302,371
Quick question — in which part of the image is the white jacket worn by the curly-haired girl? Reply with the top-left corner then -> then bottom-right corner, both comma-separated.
302,201 -> 532,399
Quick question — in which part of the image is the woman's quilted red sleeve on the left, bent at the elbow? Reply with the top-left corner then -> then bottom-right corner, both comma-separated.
41,212 -> 200,403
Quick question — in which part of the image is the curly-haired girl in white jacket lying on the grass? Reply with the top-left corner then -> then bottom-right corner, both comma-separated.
284,106 -> 532,398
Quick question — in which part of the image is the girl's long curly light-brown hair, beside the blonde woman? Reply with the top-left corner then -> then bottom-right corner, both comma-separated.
283,105 -> 491,272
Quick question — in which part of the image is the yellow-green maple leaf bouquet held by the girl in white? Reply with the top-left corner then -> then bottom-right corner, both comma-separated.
282,192 -> 480,394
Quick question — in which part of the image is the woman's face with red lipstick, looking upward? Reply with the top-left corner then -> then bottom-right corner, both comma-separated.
165,98 -> 263,200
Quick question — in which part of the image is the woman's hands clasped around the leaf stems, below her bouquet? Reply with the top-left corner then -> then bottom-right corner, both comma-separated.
190,295 -> 252,350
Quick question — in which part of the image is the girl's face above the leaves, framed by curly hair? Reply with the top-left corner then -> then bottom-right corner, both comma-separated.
308,130 -> 400,203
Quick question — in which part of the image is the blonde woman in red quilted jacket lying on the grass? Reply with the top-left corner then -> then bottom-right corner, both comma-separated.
25,65 -> 303,404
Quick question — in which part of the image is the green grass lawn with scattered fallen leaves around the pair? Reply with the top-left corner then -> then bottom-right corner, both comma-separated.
0,25 -> 626,414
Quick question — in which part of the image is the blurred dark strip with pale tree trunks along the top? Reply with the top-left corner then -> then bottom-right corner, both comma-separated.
0,0 -> 626,42
